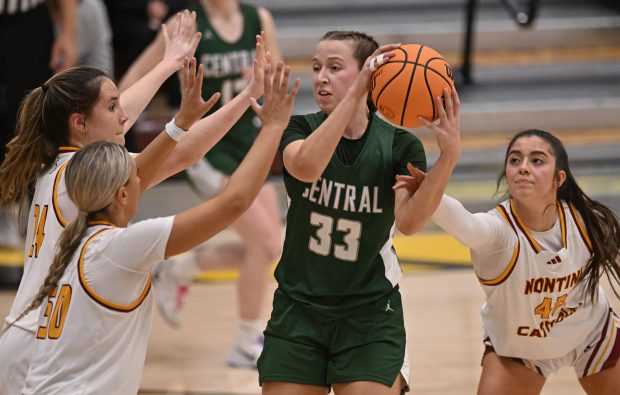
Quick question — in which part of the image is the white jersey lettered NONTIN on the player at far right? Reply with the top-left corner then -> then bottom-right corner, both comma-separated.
480,201 -> 609,359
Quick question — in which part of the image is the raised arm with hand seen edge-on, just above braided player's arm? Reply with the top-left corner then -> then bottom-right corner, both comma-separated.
151,32 -> 271,186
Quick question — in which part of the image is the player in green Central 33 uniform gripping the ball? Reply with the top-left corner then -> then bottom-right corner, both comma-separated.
258,31 -> 460,395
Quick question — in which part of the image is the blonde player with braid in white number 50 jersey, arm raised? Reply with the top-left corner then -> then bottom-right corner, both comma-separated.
22,62 -> 300,394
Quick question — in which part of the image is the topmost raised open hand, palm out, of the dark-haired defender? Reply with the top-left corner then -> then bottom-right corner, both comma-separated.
161,10 -> 202,68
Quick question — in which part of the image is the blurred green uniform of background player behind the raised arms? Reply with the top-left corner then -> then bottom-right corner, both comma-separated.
192,2 -> 261,174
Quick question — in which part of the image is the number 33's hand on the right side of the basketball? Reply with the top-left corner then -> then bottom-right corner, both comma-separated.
418,88 -> 461,165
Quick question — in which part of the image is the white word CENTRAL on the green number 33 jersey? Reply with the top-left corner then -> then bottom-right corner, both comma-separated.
302,178 -> 383,214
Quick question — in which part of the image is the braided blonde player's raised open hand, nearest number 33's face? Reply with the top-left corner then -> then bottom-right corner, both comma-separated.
251,60 -> 301,130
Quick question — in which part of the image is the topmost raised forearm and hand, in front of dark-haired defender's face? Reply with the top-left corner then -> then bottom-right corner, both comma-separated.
120,10 -> 201,132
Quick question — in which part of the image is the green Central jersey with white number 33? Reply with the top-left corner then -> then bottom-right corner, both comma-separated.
275,112 -> 426,319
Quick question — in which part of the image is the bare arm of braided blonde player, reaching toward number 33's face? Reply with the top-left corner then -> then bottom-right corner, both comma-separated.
166,62 -> 300,257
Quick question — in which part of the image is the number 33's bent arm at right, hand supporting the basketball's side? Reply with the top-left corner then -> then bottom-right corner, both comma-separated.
394,89 -> 461,235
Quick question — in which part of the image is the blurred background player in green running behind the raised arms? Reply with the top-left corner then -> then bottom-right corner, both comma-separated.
121,0 -> 282,367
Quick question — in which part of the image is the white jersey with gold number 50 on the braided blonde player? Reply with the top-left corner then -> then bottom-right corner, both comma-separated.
23,217 -> 174,395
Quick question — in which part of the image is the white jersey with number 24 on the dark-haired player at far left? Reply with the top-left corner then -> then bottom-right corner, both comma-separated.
5,147 -> 78,333
